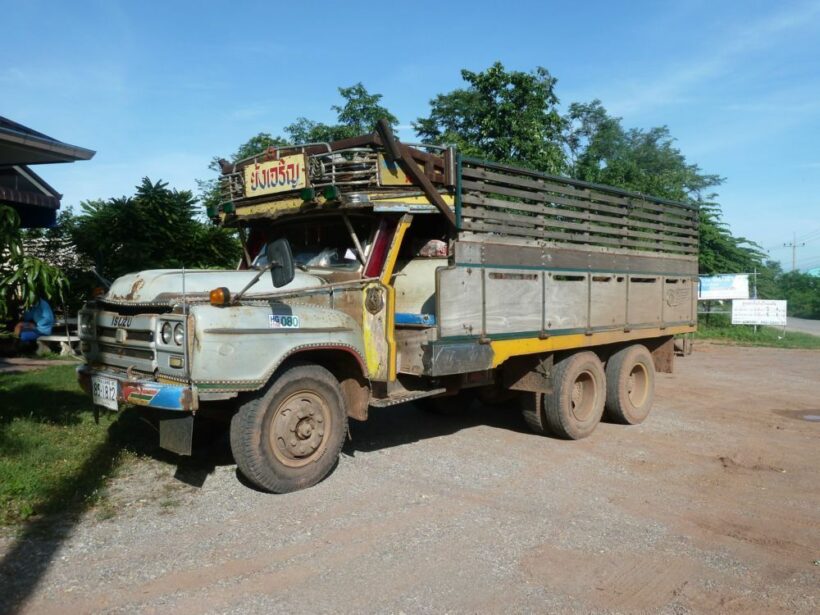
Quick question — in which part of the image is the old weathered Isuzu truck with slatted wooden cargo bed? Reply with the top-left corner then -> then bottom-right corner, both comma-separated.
78,122 -> 698,492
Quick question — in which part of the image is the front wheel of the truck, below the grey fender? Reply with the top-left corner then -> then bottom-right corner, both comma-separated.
231,364 -> 347,493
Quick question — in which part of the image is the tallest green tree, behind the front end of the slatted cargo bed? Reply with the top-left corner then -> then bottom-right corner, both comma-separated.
413,62 -> 565,173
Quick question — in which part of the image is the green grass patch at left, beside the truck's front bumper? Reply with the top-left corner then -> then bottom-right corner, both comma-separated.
0,365 -> 158,525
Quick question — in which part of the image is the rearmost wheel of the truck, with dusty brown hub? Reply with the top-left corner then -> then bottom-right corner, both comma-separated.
606,344 -> 655,425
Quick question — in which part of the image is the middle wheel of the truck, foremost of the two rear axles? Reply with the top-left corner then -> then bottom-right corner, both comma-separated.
523,352 -> 606,440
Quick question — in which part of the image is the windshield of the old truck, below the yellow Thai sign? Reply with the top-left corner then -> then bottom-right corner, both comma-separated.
248,216 -> 373,271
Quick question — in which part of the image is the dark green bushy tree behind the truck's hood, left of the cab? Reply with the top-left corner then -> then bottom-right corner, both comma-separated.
67,177 -> 241,279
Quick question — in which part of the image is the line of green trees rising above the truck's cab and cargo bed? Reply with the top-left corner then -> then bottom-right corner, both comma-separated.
200,62 -> 780,292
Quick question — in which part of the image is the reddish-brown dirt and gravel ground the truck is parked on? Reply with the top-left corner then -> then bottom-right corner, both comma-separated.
0,344 -> 820,613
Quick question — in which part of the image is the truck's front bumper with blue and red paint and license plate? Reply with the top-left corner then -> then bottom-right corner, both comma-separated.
77,365 -> 199,412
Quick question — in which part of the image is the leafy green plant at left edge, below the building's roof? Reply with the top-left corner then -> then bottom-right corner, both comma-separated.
0,205 -> 67,318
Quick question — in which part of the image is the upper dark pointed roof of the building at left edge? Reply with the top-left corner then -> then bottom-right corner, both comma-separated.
0,116 -> 96,166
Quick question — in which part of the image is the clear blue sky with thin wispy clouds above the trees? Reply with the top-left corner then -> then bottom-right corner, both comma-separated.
0,0 -> 820,268
